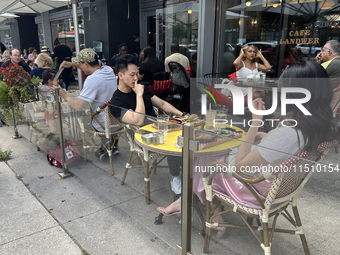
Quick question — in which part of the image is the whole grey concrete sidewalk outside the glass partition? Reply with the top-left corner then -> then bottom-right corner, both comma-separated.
0,127 -> 175,255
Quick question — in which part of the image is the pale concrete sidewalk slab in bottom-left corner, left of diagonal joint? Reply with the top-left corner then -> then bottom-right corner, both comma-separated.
0,162 -> 82,255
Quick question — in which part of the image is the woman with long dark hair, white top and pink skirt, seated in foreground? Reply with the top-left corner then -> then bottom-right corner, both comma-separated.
157,62 -> 338,238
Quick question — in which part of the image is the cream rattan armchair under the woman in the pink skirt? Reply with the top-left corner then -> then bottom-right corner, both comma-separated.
203,141 -> 337,255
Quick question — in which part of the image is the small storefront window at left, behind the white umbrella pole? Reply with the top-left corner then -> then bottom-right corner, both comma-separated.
51,17 -> 85,52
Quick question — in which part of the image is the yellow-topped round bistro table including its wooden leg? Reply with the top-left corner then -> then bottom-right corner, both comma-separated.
135,124 -> 245,204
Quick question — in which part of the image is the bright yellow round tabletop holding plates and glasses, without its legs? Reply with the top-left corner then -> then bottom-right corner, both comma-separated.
135,125 -> 245,156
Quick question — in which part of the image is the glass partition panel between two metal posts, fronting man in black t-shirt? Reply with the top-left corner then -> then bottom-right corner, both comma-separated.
30,92 -> 183,249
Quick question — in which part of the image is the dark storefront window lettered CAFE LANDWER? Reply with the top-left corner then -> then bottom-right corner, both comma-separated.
215,0 -> 340,77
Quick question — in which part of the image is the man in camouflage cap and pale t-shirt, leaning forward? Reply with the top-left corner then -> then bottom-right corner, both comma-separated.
56,48 -> 119,159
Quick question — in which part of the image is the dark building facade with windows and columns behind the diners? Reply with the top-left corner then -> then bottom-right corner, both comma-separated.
2,0 -> 340,77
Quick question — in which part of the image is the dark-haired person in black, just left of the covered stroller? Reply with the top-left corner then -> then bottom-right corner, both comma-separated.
138,46 -> 165,84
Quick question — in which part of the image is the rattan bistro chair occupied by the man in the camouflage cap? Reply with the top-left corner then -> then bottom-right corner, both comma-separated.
78,100 -> 127,175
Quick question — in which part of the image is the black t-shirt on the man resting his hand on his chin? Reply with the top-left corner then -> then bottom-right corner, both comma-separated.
110,86 -> 157,117
